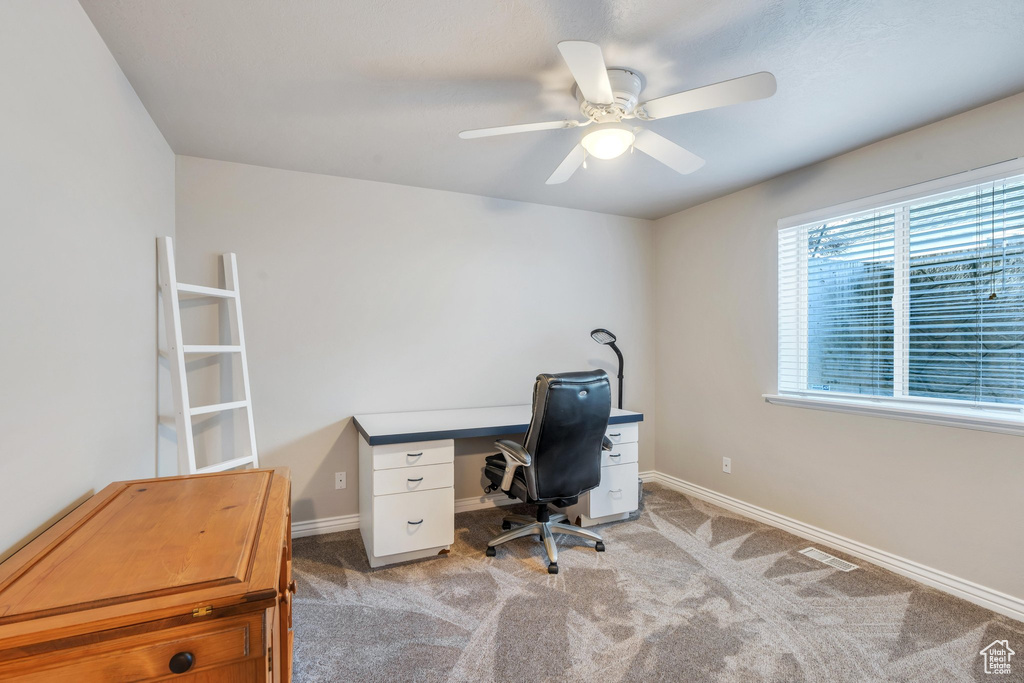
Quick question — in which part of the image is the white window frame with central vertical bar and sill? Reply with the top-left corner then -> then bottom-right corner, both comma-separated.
763,158 -> 1024,435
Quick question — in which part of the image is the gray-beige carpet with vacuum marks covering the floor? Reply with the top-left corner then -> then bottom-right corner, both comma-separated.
294,485 -> 1024,683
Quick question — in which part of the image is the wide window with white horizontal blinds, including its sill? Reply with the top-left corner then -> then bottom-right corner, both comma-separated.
768,162 -> 1024,433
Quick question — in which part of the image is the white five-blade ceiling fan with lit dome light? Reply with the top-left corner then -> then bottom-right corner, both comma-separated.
459,40 -> 775,185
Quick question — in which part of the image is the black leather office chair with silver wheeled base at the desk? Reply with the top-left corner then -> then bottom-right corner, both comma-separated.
483,371 -> 611,573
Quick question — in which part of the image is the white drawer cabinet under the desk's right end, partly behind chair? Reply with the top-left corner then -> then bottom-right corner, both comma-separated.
565,422 -> 640,526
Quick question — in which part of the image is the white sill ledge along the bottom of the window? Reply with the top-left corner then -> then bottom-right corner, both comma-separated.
764,393 -> 1024,436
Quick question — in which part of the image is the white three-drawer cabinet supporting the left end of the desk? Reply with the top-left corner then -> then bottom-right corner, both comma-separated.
359,438 -> 455,567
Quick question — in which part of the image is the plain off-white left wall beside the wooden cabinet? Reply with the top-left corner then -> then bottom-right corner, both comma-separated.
0,0 -> 174,558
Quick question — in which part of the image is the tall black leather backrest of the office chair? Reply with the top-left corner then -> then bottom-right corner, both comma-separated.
523,370 -> 611,500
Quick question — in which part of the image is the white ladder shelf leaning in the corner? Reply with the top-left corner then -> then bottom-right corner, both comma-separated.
157,238 -> 259,474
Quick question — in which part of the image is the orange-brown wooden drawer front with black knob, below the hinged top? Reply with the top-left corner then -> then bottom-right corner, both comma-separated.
0,612 -> 256,683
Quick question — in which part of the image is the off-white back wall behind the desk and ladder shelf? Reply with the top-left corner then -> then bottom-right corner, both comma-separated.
177,157 -> 654,521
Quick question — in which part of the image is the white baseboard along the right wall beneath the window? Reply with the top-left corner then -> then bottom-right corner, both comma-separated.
640,472 -> 1024,622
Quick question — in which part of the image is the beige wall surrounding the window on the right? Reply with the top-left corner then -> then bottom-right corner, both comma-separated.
655,90 -> 1024,597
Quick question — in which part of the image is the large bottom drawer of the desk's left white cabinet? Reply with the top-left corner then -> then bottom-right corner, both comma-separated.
373,489 -> 454,557
